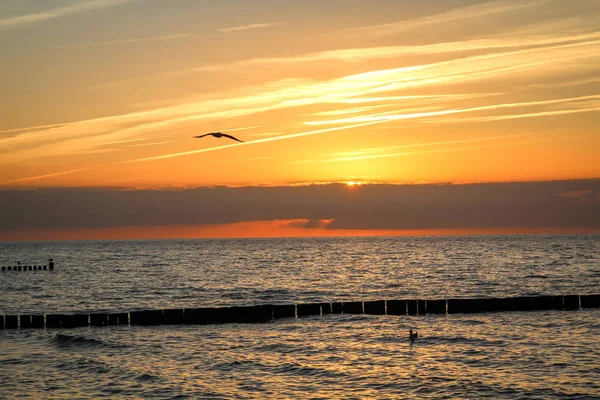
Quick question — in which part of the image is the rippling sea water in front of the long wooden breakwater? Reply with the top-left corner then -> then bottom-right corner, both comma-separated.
0,310 -> 600,399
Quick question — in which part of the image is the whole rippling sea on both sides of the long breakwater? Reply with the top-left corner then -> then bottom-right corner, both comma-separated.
0,235 -> 600,399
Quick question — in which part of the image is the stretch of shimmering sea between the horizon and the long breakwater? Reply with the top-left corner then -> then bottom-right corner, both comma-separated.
0,235 -> 600,313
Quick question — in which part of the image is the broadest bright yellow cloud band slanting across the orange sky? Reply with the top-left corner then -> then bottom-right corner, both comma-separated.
0,35 -> 600,163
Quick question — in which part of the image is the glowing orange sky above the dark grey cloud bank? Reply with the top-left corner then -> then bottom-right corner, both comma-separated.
0,0 -> 600,241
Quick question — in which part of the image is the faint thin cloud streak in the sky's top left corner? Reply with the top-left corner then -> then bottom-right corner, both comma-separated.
0,0 -> 131,31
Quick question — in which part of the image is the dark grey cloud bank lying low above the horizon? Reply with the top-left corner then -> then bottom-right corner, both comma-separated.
0,179 -> 600,232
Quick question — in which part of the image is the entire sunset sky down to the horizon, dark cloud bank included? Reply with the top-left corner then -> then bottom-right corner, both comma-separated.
0,0 -> 600,240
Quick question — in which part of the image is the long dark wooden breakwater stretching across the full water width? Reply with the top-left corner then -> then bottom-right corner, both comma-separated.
0,294 -> 600,329
